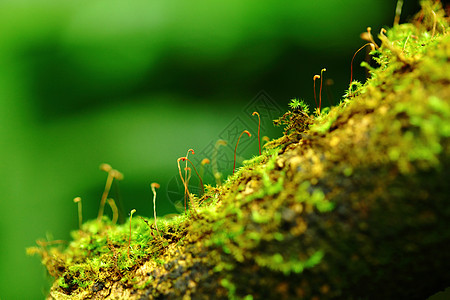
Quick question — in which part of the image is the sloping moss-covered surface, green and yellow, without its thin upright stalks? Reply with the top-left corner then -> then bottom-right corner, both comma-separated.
29,1 -> 450,299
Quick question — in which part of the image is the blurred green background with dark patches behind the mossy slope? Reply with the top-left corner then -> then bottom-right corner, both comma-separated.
0,0 -> 446,299
